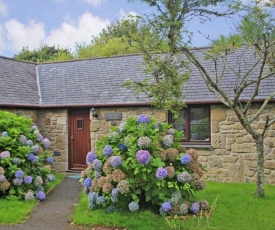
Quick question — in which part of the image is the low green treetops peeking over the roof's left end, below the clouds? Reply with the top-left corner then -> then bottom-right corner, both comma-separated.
13,45 -> 73,62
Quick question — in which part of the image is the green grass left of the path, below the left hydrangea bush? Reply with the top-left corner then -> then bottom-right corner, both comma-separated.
0,173 -> 65,225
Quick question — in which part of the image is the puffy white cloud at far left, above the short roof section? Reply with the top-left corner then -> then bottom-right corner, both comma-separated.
0,19 -> 45,52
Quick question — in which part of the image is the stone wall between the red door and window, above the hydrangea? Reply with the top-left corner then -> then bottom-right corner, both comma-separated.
90,107 -> 167,149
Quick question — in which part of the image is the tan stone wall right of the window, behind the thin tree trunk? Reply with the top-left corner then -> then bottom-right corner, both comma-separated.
198,105 -> 275,184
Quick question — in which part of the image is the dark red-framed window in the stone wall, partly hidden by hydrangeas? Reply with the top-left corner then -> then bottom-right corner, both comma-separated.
170,106 -> 211,144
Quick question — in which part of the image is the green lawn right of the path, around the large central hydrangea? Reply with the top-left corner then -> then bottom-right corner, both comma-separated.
72,182 -> 275,230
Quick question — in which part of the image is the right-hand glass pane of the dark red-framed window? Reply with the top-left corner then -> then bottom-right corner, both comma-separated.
190,108 -> 210,141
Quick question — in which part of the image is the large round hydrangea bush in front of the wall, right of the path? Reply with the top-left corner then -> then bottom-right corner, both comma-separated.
80,114 -> 208,216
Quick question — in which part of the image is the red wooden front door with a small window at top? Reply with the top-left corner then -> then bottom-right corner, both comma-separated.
69,110 -> 91,170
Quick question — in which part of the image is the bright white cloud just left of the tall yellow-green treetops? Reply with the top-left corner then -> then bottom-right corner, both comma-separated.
44,13 -> 110,48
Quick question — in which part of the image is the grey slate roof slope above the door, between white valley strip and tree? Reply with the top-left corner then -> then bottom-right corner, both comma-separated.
38,55 -> 150,106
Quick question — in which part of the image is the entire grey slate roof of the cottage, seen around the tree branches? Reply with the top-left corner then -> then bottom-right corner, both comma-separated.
0,48 -> 275,107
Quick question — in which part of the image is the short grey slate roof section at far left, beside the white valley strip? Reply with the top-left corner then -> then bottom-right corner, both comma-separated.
0,56 -> 39,106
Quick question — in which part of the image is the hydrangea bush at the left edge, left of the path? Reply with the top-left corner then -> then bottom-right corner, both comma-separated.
0,111 -> 54,200
